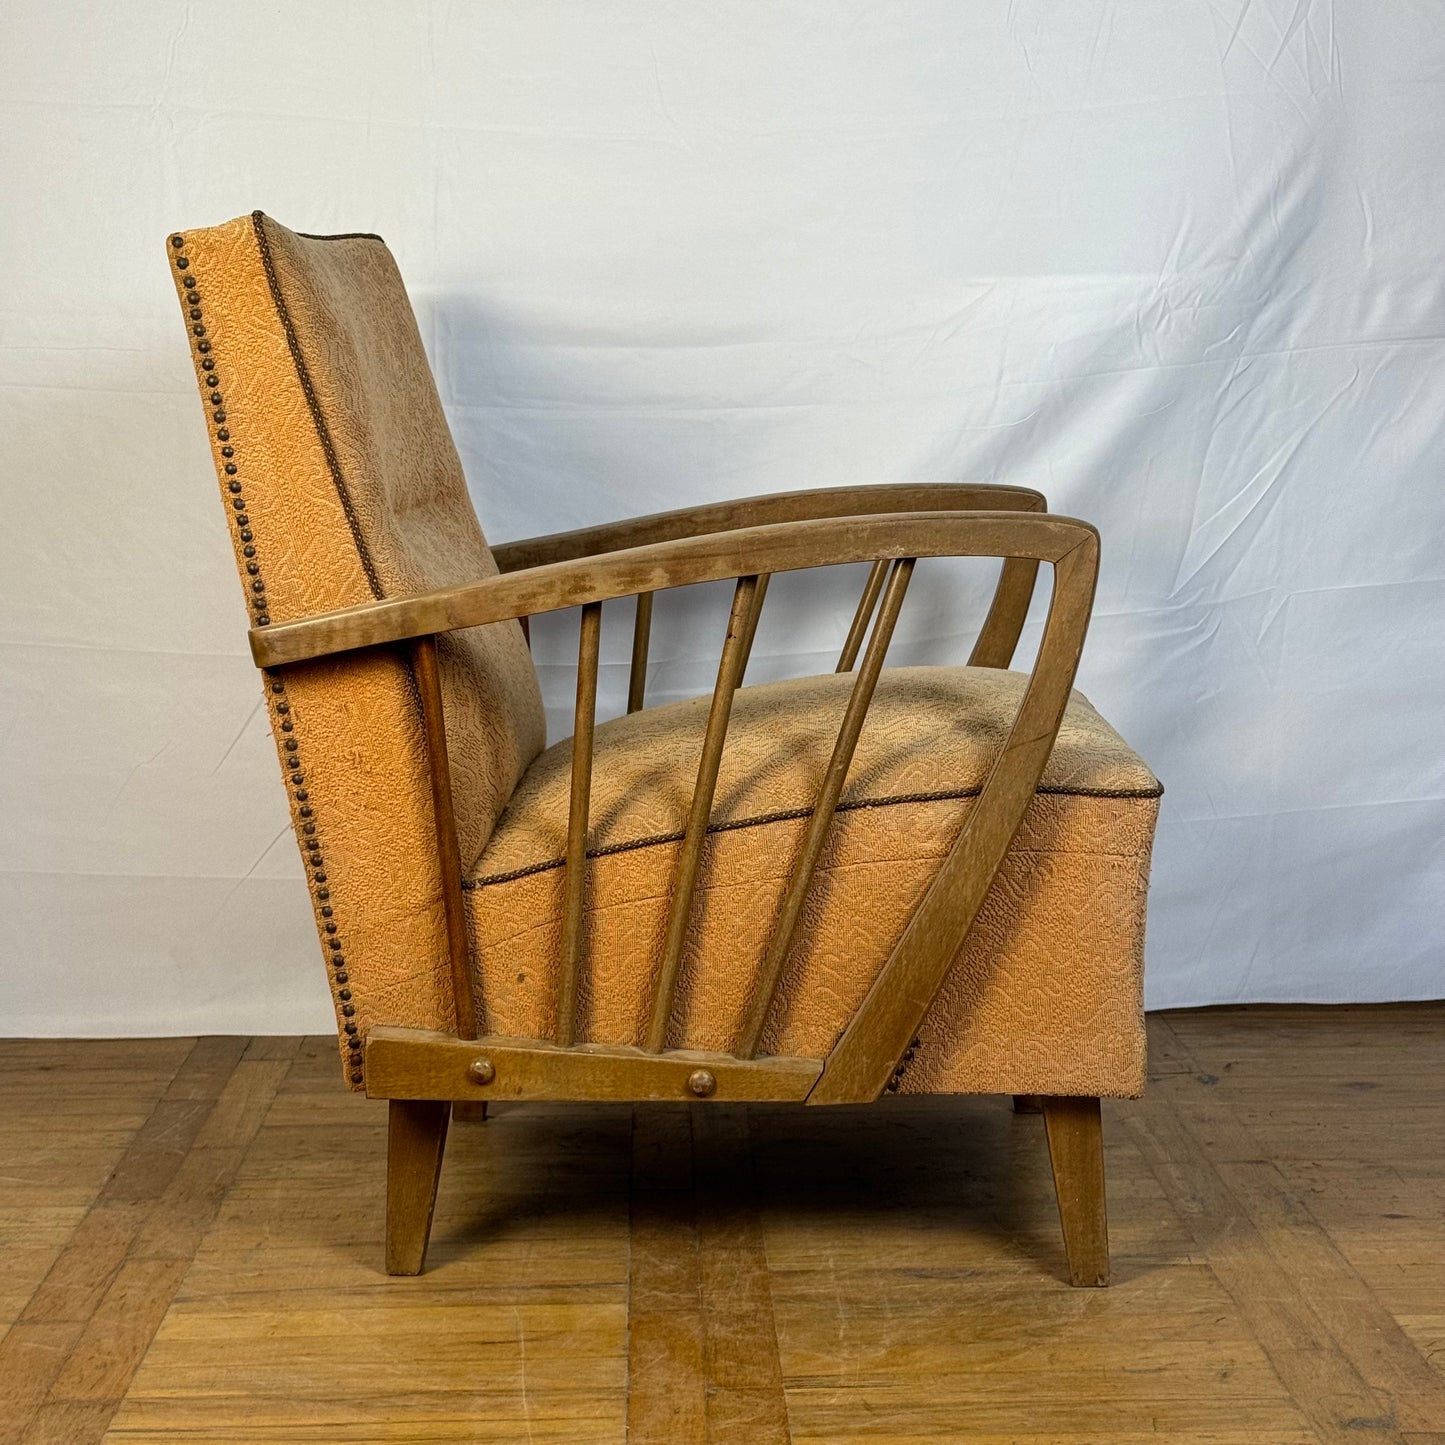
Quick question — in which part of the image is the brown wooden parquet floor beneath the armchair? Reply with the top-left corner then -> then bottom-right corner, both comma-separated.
0,1004 -> 1445,1445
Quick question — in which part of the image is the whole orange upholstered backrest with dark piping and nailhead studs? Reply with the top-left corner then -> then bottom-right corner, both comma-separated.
168,212 -> 545,1087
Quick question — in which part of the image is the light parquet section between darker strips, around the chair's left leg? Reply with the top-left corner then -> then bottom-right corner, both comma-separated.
107,1063 -> 630,1442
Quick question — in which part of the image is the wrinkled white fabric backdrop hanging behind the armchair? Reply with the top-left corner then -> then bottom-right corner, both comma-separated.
0,0 -> 1445,1033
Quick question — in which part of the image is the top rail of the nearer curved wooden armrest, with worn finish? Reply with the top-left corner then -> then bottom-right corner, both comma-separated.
250,512 -> 1097,668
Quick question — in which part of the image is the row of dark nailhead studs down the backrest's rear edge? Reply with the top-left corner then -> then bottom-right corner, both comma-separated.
171,236 -> 364,1084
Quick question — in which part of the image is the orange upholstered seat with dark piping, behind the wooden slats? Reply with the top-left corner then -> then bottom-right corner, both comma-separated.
467,668 -> 1160,1094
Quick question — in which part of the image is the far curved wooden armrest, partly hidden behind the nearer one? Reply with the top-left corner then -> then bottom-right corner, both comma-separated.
491,481 -> 1048,572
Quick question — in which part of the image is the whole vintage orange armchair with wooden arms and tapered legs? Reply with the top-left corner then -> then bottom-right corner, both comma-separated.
168,212 -> 1160,1285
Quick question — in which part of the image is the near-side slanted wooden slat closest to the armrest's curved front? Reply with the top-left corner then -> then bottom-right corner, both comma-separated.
737,558 -> 913,1059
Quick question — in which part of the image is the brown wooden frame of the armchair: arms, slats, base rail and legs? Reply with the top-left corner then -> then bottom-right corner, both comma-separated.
250,484 -> 1108,1285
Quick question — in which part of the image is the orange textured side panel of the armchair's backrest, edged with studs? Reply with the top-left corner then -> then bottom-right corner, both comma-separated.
168,218 -> 452,1088
